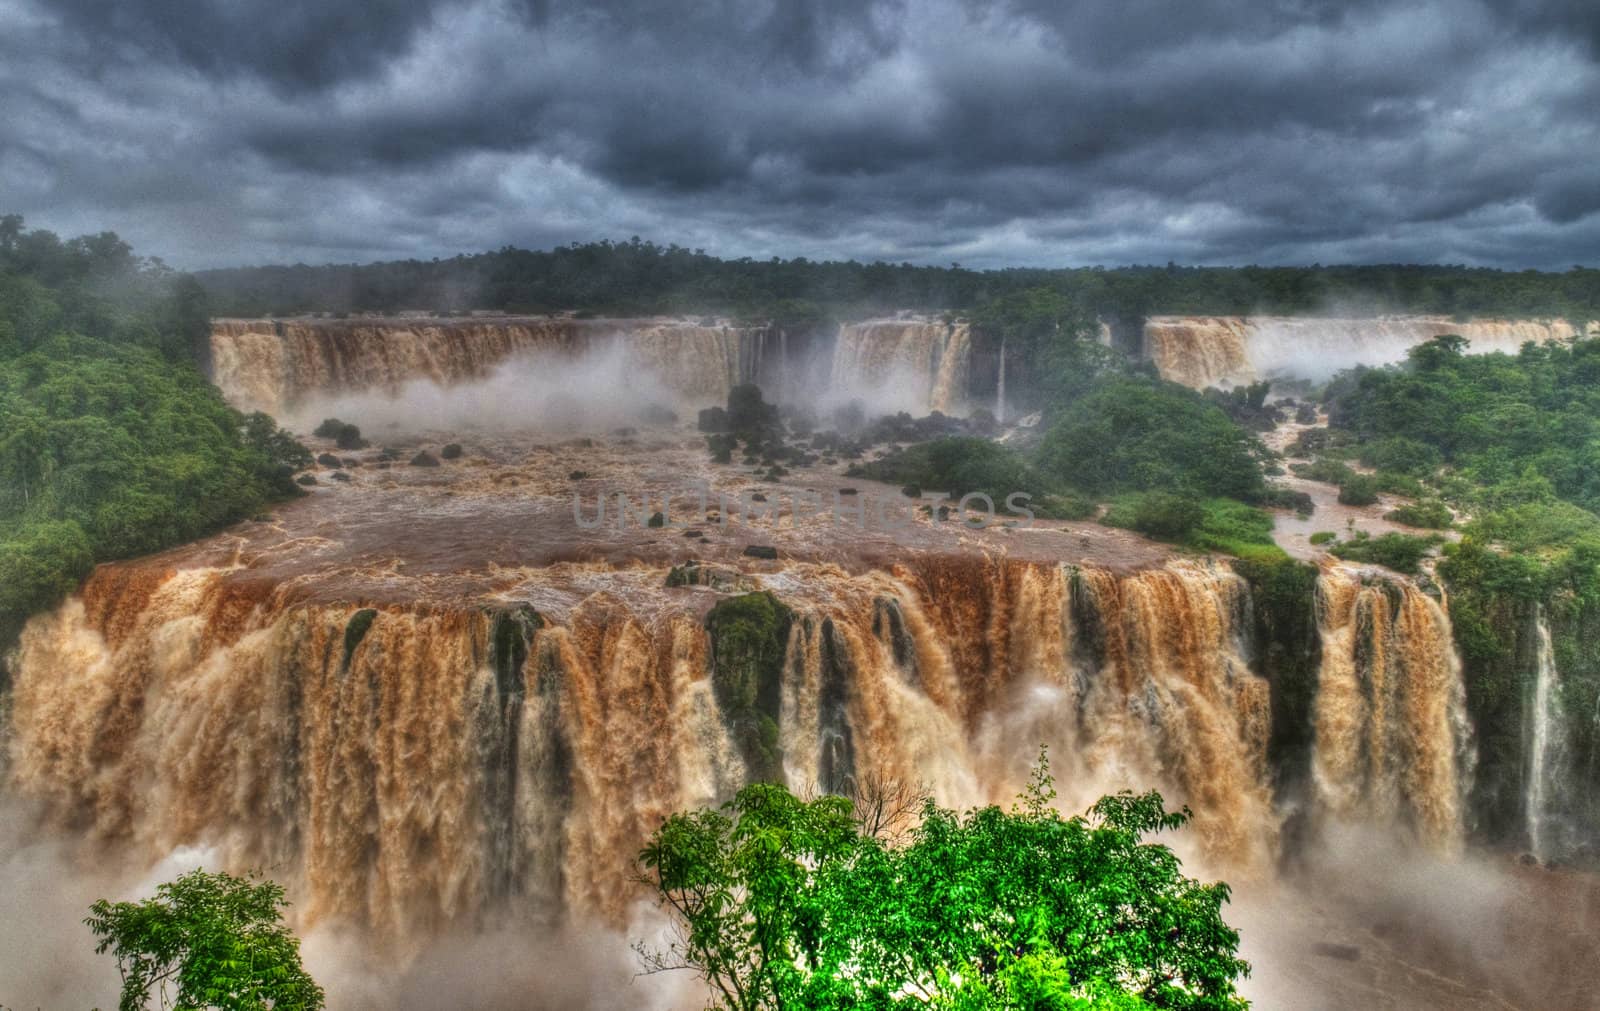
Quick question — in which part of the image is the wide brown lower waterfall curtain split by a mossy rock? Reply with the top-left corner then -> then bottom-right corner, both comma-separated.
10,558 -> 1312,937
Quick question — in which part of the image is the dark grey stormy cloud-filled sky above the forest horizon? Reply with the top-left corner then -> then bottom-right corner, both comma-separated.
0,0 -> 1600,269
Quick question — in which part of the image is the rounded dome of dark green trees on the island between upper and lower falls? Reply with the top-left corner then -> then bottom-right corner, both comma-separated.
1037,376 -> 1266,501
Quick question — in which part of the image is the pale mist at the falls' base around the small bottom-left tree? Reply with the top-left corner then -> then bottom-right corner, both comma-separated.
0,798 -> 701,1011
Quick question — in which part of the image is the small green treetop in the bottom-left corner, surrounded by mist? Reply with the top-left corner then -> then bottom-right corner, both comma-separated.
85,870 -> 323,1011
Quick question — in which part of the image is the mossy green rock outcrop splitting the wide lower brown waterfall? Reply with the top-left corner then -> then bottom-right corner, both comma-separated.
706,593 -> 792,781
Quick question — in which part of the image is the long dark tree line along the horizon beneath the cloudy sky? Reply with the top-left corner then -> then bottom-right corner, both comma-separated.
195,237 -> 1600,325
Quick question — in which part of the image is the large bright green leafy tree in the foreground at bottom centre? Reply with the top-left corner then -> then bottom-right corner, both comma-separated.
638,755 -> 1250,1011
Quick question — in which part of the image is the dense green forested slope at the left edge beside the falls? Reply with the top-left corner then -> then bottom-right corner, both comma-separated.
0,220 -> 310,678
